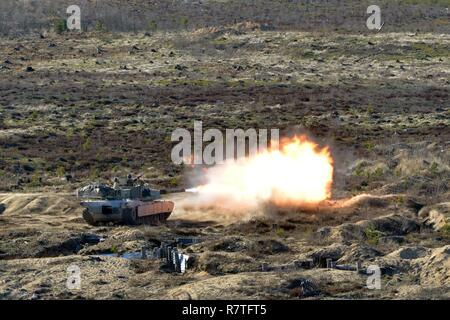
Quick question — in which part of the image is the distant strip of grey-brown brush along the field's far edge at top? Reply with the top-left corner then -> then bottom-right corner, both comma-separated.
0,0 -> 450,35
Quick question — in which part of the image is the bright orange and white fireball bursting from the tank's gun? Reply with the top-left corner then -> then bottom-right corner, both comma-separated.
192,136 -> 333,206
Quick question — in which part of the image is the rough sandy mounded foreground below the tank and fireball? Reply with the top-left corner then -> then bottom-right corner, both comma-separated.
0,190 -> 450,299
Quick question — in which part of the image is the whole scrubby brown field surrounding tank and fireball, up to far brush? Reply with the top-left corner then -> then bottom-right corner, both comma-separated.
0,24 -> 450,299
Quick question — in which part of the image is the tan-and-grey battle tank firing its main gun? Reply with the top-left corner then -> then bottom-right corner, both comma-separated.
77,175 -> 184,225
